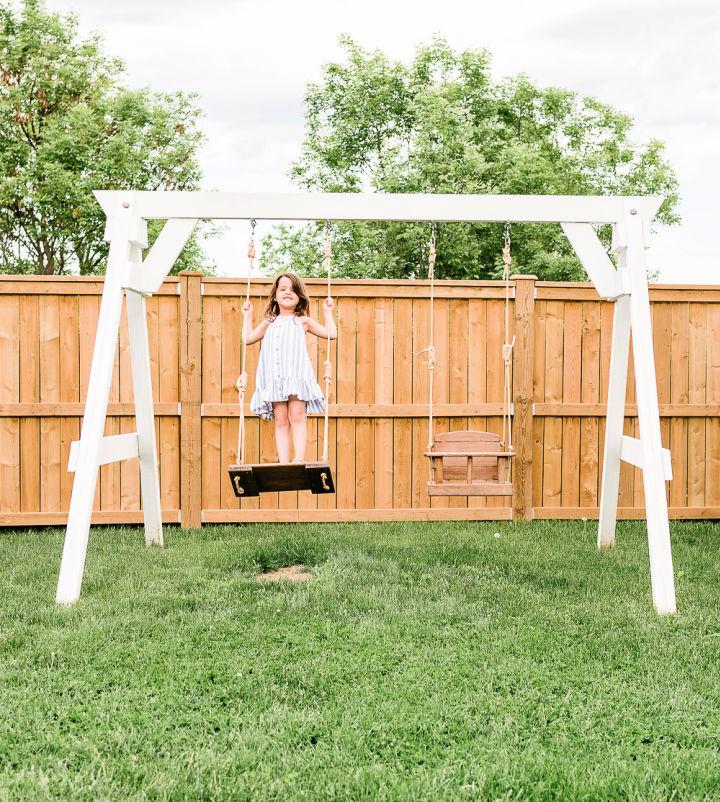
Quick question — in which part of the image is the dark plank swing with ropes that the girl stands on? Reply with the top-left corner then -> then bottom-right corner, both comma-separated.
228,219 -> 335,498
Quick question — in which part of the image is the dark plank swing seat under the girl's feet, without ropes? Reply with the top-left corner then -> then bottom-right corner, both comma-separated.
228,462 -> 335,498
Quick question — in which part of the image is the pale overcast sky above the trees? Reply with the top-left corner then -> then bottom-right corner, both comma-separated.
47,0 -> 720,283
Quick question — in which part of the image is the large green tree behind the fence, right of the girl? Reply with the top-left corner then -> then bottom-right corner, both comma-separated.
262,37 -> 678,280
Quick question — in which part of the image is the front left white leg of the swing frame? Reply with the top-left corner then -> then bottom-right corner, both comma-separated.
56,201 -> 147,604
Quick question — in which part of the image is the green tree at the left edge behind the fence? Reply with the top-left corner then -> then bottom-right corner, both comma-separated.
0,0 -> 211,275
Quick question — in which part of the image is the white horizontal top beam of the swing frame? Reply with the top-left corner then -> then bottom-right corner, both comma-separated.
95,191 -> 662,223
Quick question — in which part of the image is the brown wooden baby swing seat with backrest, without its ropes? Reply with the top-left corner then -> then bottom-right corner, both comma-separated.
425,431 -> 515,496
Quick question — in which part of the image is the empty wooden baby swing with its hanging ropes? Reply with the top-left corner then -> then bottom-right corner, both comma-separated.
420,223 -> 515,496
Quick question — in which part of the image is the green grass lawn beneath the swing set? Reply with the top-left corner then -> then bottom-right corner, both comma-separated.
0,522 -> 720,802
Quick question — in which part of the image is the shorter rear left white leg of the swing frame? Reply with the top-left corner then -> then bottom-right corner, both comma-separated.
125,290 -> 163,546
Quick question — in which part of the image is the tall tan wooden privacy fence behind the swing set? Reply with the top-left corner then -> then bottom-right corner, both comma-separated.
0,273 -> 720,526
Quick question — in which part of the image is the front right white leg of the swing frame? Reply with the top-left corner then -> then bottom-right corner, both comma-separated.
627,212 -> 676,614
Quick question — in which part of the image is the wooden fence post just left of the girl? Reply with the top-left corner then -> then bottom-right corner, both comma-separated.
178,270 -> 202,529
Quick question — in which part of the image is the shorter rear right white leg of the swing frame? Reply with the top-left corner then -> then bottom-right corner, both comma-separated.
598,295 -> 630,549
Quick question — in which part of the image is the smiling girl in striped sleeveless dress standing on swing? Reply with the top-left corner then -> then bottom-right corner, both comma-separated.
243,273 -> 337,462
